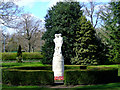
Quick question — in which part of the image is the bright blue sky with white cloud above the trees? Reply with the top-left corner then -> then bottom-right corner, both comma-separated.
6,0 -> 110,33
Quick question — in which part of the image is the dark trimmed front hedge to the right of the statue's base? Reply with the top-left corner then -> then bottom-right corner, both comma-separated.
64,68 -> 118,85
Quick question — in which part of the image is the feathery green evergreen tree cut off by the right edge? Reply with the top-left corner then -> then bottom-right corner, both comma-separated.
101,0 -> 120,63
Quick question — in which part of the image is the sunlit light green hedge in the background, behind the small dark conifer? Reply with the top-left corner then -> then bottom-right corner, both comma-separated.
2,52 -> 43,61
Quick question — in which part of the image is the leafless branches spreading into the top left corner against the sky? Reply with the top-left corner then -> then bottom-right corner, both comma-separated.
0,0 -> 22,28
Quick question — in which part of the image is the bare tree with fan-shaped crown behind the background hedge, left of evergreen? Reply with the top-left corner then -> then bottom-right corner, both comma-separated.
17,14 -> 42,52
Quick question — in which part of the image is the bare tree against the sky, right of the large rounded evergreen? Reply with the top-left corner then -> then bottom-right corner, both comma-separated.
83,0 -> 104,28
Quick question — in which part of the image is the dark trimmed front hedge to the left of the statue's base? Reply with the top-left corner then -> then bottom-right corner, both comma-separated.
2,69 -> 54,85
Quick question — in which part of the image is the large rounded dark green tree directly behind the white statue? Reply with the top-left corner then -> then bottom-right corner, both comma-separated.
42,1 -> 82,64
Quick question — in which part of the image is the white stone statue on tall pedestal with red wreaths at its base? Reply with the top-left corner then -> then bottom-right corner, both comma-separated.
52,34 -> 64,80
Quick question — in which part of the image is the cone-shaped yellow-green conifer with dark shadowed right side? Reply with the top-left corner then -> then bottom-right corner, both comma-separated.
71,16 -> 106,65
